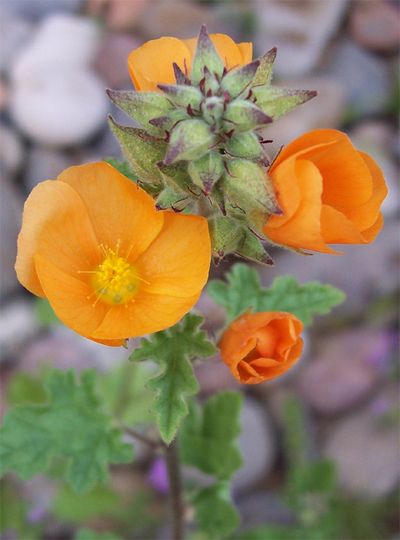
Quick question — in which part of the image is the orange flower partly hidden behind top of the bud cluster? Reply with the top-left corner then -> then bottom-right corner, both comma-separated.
128,34 -> 253,92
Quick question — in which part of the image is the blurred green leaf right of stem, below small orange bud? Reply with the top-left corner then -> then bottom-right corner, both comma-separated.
179,392 -> 242,480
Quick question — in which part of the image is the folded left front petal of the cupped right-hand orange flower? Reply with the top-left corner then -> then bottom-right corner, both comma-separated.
264,159 -> 333,253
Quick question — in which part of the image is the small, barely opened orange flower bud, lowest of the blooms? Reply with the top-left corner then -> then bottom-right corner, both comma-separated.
219,311 -> 303,384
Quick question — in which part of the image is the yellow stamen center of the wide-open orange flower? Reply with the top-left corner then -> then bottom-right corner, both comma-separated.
91,248 -> 143,305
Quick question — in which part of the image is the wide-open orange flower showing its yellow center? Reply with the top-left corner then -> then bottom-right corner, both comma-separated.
15,162 -> 211,346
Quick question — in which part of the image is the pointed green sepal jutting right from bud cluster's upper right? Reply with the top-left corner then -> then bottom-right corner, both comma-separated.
253,86 -> 317,119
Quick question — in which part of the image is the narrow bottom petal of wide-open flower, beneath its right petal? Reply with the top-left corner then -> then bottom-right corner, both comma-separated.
92,291 -> 200,339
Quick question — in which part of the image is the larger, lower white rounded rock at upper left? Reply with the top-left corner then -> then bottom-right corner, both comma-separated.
11,69 -> 108,146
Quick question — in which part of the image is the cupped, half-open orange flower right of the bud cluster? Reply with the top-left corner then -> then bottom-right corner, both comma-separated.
264,129 -> 387,253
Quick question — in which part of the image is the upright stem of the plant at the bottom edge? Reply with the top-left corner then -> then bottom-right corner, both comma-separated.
164,439 -> 184,540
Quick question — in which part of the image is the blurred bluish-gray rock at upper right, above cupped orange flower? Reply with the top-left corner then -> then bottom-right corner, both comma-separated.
324,41 -> 393,116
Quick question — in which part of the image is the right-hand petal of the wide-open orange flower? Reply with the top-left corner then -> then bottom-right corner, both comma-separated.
135,212 -> 211,297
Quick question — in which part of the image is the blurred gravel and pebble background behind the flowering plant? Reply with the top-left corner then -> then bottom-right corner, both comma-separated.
0,0 -> 400,540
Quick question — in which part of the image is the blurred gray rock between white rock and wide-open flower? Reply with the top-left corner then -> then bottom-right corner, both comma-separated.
24,145 -> 78,191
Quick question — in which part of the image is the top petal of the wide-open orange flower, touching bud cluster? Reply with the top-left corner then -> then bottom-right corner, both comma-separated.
58,162 -> 164,260
